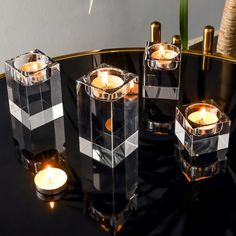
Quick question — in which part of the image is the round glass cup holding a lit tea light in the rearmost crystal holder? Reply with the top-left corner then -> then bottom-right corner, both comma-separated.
147,43 -> 180,70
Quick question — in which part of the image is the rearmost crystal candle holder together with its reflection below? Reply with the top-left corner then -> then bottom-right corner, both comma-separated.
142,42 -> 181,134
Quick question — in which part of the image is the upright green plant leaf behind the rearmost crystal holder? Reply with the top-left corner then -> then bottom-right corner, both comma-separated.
179,0 -> 188,49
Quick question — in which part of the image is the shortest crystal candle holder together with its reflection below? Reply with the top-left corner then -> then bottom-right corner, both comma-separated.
175,100 -> 230,181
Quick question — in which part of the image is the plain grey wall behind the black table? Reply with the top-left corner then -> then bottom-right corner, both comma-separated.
0,0 -> 224,72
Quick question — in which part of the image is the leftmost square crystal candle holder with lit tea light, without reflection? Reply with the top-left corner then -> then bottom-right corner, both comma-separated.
5,49 -> 63,130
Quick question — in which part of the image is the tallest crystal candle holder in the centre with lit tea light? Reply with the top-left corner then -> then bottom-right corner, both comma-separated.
77,64 -> 138,168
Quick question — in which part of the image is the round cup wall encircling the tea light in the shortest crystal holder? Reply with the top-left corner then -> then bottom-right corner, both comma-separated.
185,103 -> 222,136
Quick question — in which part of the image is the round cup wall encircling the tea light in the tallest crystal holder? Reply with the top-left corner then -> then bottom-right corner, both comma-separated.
87,67 -> 125,101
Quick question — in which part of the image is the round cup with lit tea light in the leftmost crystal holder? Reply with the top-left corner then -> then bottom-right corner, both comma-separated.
14,52 -> 50,86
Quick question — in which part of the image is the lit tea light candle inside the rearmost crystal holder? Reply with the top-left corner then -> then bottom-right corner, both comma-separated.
151,44 -> 178,69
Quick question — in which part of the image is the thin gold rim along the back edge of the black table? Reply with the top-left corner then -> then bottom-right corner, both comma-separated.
0,47 -> 236,80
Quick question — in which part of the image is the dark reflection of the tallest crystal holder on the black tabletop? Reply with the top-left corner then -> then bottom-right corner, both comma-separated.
80,154 -> 138,235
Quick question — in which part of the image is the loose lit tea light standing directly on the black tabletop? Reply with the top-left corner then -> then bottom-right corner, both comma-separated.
34,166 -> 67,195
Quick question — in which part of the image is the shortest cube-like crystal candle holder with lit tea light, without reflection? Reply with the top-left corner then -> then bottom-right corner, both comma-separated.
175,100 -> 230,156
